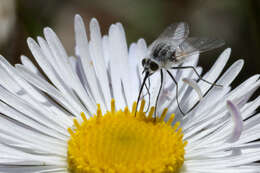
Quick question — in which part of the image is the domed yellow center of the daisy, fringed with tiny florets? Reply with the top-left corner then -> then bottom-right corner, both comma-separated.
67,100 -> 187,173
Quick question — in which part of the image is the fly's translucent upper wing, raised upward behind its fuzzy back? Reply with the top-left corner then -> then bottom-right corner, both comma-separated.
149,22 -> 189,52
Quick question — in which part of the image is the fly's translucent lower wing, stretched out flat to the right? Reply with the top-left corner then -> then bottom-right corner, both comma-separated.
175,37 -> 225,60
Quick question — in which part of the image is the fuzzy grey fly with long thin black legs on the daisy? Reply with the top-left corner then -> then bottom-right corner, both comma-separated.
136,22 -> 225,116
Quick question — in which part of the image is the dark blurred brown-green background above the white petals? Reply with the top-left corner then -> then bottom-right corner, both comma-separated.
0,0 -> 260,90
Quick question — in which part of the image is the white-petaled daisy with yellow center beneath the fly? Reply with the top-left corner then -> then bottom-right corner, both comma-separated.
0,15 -> 260,173
